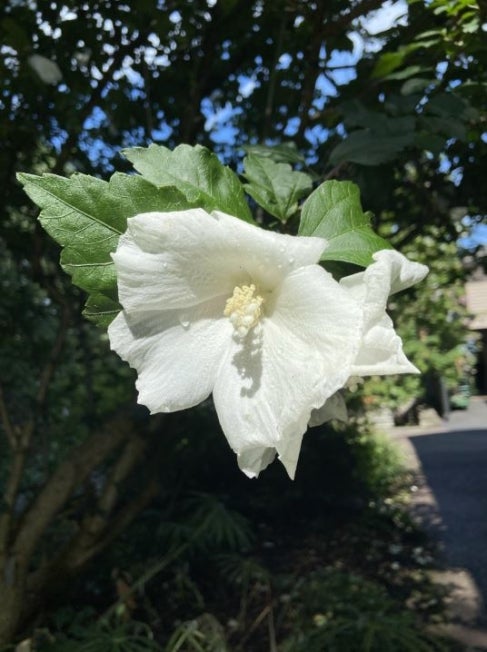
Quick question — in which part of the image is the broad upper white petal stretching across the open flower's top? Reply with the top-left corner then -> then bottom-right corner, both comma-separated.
113,209 -> 326,312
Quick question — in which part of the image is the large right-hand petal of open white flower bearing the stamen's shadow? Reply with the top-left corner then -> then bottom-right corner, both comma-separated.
213,265 -> 361,477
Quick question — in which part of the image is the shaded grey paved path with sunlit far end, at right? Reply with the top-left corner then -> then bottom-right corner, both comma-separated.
393,397 -> 487,628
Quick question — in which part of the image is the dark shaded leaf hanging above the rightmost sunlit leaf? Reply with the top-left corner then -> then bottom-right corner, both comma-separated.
330,129 -> 414,165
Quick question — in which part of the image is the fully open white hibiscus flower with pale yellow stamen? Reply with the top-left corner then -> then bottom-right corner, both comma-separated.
108,209 -> 363,477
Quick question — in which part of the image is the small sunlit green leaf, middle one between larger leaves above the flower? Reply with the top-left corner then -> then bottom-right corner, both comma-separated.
244,154 -> 313,222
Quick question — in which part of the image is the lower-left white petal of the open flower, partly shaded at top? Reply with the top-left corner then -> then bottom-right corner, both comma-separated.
108,301 -> 233,413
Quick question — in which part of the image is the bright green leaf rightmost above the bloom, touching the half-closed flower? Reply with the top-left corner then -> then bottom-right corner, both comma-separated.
299,181 -> 392,267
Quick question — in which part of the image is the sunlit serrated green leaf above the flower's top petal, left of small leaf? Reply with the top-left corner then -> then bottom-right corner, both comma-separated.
123,145 -> 253,222
